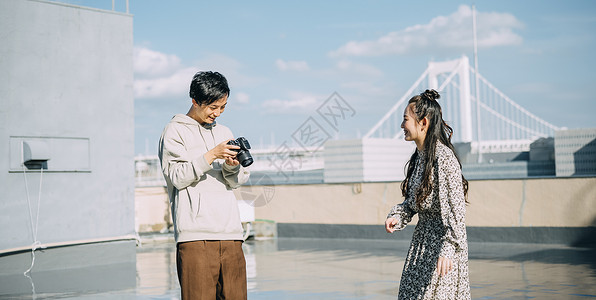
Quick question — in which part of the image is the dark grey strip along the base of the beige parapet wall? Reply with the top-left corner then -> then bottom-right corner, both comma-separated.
277,223 -> 596,247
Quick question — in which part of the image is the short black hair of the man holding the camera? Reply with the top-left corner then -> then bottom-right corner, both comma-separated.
189,71 -> 230,105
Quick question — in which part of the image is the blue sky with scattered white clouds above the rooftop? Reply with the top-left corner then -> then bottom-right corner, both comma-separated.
66,0 -> 596,155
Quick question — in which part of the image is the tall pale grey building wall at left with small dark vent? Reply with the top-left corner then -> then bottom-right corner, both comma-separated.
0,0 -> 134,251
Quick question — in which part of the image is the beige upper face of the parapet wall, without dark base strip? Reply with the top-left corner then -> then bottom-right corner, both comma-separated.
255,177 -> 596,227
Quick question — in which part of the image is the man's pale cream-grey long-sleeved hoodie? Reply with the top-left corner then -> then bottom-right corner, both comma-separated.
158,114 -> 250,242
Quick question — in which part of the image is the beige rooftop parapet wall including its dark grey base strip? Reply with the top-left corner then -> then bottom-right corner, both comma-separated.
135,177 -> 596,245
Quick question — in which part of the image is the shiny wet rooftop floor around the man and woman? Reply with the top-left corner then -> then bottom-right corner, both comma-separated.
0,237 -> 596,300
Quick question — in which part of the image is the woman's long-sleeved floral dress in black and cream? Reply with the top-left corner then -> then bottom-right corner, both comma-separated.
387,142 -> 470,299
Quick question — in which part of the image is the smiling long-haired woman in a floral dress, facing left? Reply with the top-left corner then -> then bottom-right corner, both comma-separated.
385,90 -> 470,299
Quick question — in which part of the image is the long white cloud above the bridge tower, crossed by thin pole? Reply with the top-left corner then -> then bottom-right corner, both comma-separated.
329,5 -> 523,57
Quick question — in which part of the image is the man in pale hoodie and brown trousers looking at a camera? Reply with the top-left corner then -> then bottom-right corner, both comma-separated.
159,72 -> 250,300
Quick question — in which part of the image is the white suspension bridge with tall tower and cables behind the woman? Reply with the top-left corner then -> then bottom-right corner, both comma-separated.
364,56 -> 560,152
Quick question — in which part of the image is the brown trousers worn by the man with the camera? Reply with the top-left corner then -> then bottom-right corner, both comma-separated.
176,241 -> 247,300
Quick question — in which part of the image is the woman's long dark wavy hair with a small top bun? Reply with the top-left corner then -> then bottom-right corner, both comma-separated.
401,90 -> 468,207
